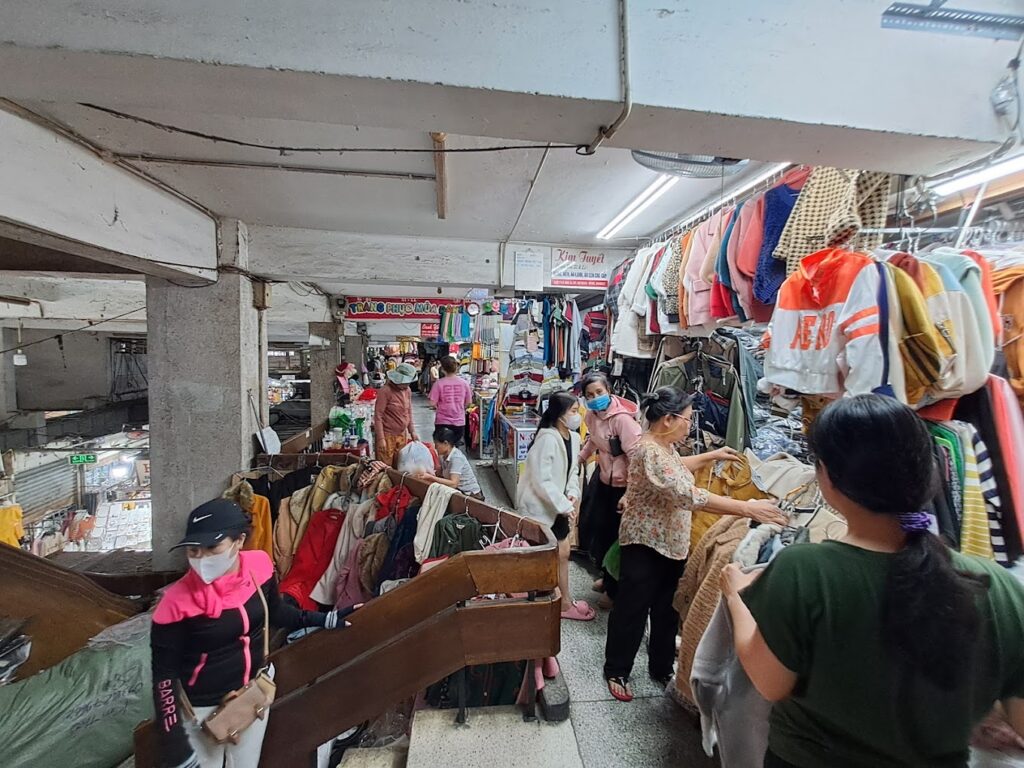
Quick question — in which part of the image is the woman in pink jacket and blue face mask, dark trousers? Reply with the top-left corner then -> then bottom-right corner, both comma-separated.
580,372 -> 641,608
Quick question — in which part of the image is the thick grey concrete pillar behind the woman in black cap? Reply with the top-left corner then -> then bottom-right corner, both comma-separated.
146,220 -> 266,569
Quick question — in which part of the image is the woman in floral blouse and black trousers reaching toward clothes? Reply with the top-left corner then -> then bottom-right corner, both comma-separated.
604,387 -> 786,701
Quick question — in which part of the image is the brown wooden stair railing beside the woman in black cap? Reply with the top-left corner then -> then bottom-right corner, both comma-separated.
135,454 -> 560,768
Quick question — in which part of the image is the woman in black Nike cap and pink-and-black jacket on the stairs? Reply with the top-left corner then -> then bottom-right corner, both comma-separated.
150,499 -> 359,768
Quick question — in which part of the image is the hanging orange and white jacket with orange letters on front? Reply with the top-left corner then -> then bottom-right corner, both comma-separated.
765,248 -> 902,396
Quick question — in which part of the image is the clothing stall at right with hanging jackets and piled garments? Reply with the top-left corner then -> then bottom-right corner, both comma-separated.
593,160 -> 1024,765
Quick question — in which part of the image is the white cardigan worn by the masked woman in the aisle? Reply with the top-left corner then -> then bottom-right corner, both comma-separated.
515,427 -> 580,525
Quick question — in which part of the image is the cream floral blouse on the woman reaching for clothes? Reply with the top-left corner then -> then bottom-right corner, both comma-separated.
618,439 -> 708,560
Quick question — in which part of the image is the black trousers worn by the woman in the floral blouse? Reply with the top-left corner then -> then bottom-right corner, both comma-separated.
604,544 -> 686,679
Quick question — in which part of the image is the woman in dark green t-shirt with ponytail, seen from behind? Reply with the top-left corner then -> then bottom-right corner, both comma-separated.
722,395 -> 1024,768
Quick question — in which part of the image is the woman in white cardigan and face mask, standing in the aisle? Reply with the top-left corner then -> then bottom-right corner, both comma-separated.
516,392 -> 595,622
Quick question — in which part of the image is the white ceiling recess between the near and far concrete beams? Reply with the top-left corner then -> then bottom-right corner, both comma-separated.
25,103 -> 762,245
